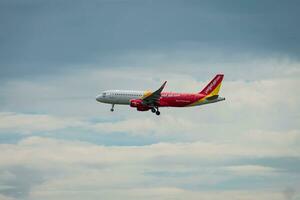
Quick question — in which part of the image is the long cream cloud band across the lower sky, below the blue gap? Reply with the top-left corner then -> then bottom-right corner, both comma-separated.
0,136 -> 299,172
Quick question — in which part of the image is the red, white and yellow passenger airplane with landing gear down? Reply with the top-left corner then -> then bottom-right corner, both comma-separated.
96,74 -> 225,115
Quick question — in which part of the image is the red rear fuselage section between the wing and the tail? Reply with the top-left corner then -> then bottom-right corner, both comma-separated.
159,92 -> 205,107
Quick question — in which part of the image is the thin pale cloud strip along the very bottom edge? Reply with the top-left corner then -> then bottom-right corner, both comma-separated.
31,187 -> 290,200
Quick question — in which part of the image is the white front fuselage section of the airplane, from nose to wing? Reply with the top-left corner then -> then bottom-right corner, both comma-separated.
96,90 -> 145,105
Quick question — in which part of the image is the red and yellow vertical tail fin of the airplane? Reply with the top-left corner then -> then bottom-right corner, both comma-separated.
199,74 -> 224,97
